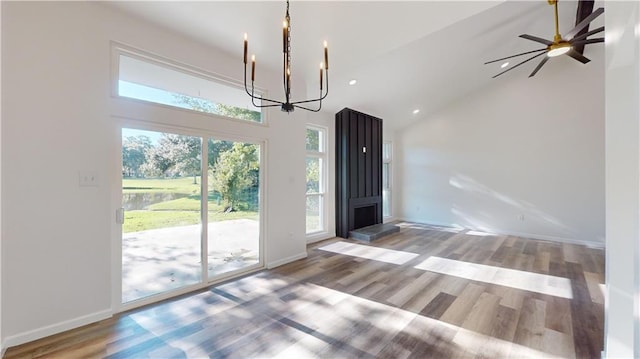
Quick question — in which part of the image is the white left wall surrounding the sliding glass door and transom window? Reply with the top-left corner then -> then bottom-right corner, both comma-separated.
1,2 -> 307,345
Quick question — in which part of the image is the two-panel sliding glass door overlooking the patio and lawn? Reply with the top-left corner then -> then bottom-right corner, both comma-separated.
120,128 -> 262,303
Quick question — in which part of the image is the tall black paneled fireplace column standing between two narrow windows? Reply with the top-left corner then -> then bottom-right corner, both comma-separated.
336,108 -> 382,238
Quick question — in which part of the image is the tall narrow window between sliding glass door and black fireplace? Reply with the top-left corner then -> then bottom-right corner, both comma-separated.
306,126 -> 327,234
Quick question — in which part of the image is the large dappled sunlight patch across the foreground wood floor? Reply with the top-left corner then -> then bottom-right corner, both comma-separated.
122,262 -> 568,358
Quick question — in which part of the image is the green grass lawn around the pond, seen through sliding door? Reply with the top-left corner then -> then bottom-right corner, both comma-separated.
122,177 -> 258,233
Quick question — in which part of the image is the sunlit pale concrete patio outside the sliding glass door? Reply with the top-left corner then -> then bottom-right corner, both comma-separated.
122,219 -> 260,303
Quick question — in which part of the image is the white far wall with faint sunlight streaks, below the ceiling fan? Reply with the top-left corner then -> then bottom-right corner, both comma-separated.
396,45 -> 604,246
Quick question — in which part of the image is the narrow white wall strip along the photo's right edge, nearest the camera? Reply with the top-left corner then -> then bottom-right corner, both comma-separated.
605,1 -> 640,358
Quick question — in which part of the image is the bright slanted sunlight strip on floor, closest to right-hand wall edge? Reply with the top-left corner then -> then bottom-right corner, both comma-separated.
414,257 -> 573,299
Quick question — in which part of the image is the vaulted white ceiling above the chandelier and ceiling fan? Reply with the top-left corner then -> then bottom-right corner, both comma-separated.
108,0 -> 604,128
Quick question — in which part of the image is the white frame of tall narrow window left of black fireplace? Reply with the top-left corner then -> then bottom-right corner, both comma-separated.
305,124 -> 329,238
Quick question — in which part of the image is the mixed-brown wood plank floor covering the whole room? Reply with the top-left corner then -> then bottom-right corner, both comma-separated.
5,223 -> 604,359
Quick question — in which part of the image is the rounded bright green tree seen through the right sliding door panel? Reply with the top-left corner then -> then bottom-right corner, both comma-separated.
211,142 -> 259,210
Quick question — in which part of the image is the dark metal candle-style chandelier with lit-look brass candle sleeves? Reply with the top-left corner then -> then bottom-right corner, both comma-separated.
244,0 -> 329,112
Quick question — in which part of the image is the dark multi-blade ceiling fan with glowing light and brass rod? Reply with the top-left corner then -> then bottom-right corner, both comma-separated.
484,0 -> 604,78
